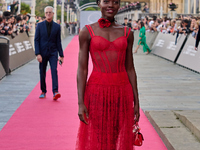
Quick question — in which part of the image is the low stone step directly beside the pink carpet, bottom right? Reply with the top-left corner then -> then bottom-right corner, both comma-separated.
145,110 -> 200,150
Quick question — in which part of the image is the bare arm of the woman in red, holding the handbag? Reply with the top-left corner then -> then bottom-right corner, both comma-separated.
125,31 -> 140,122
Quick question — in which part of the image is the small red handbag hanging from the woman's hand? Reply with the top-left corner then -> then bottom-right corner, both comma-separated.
133,122 -> 144,146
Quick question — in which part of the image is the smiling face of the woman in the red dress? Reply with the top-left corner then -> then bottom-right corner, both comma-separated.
99,0 -> 120,18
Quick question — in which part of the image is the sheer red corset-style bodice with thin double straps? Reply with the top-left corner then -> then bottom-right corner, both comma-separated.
86,26 -> 130,85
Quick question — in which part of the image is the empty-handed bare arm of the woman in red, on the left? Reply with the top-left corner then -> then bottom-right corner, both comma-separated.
77,27 -> 90,124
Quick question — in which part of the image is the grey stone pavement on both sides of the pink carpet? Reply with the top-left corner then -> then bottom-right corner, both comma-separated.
0,36 -> 200,150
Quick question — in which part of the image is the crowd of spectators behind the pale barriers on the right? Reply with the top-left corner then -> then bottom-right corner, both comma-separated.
124,16 -> 200,38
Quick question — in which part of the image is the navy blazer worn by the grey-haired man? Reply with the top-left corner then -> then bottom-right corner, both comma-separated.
35,21 -> 63,57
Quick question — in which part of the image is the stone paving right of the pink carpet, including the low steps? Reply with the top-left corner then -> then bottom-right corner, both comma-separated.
134,44 -> 200,150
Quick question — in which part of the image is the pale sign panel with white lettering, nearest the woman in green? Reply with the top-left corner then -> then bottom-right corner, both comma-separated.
152,33 -> 186,62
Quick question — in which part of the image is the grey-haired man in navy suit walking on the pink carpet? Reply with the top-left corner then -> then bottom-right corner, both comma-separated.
35,6 -> 64,100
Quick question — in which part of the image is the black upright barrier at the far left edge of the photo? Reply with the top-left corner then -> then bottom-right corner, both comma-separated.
0,36 -> 10,75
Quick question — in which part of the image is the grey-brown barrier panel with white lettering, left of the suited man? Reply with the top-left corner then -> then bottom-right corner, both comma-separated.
9,33 -> 35,71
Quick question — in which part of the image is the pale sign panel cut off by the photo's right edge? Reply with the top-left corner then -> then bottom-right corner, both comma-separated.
177,35 -> 200,72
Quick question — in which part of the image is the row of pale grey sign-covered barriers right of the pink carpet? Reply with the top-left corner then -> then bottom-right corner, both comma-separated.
133,31 -> 200,73
